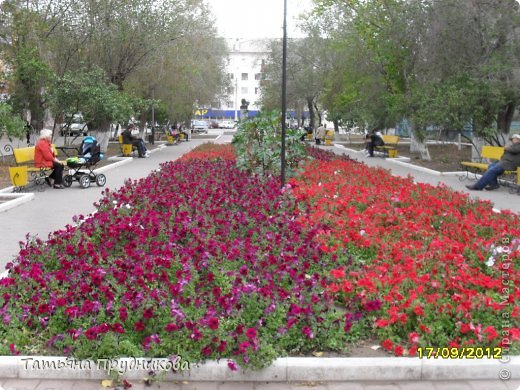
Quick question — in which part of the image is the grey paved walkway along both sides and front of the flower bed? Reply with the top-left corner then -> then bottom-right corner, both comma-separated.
0,135 -> 520,390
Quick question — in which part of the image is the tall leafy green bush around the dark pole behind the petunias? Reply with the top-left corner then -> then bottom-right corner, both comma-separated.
233,111 -> 305,175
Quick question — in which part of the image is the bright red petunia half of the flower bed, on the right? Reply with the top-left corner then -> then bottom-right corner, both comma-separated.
291,149 -> 520,355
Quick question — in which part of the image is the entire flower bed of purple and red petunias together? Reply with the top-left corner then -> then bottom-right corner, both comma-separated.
0,144 -> 520,369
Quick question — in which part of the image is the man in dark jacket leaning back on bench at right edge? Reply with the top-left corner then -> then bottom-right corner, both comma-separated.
466,134 -> 520,191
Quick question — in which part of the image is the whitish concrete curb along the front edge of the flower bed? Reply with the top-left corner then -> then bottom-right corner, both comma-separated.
0,356 -> 520,382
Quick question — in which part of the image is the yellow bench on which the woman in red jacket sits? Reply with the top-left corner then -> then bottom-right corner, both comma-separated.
9,144 -> 61,192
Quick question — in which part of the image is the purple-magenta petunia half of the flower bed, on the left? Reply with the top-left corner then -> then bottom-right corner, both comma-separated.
0,145 -> 349,369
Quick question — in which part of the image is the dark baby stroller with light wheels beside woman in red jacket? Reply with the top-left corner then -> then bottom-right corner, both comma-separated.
63,136 -> 107,188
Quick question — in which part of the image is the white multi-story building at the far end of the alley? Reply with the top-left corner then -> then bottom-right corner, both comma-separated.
211,39 -> 270,120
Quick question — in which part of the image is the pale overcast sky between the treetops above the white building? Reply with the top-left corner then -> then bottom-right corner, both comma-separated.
207,0 -> 312,38
